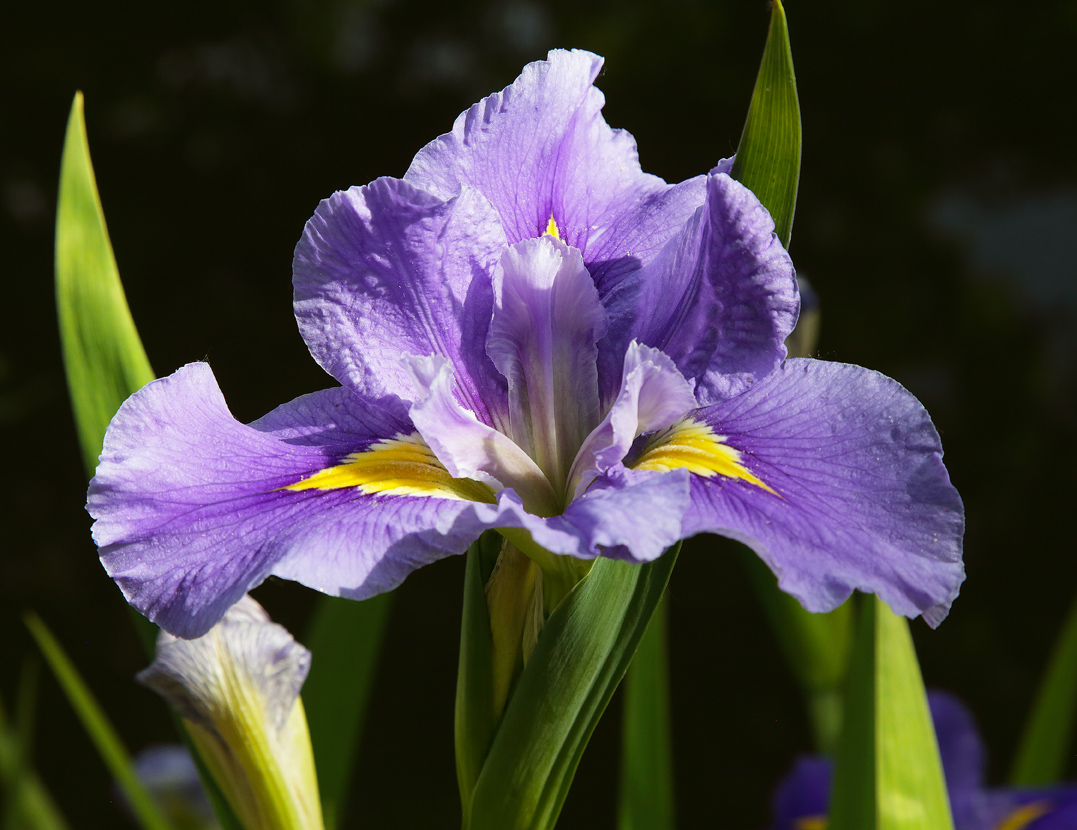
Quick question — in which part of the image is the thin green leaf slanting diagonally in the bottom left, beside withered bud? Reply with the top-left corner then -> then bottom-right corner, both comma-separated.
26,614 -> 169,830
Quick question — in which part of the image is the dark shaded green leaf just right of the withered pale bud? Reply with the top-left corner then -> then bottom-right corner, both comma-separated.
303,593 -> 392,828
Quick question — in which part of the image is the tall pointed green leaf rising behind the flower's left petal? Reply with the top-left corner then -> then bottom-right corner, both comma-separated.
56,93 -> 154,475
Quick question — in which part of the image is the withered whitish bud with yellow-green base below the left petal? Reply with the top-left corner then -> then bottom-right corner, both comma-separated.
138,596 -> 322,830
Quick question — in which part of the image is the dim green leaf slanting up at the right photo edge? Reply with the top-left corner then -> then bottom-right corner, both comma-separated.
1010,602 -> 1077,787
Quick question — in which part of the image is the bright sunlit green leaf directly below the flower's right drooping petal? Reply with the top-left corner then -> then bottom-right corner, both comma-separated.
827,596 -> 953,830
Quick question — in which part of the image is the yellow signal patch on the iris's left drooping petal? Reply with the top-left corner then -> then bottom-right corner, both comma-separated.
281,433 -> 496,504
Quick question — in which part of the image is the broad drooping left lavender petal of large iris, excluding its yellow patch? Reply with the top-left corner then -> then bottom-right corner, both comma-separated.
87,364 -> 493,637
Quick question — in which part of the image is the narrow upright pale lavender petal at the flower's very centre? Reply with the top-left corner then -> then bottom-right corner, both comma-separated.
486,236 -> 606,495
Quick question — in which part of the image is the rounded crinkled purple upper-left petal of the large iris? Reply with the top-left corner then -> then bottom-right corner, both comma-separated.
293,179 -> 505,423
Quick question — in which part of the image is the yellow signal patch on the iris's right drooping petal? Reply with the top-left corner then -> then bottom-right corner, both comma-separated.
632,418 -> 781,497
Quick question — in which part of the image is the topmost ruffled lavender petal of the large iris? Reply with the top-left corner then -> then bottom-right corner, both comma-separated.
405,50 -> 703,279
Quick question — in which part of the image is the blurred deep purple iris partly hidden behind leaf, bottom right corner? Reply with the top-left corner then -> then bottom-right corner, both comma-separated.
771,691 -> 1077,830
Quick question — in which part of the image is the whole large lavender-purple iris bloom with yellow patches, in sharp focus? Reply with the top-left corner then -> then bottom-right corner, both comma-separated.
88,51 -> 964,637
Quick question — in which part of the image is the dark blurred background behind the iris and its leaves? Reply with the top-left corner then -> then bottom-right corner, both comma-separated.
0,0 -> 1077,829
